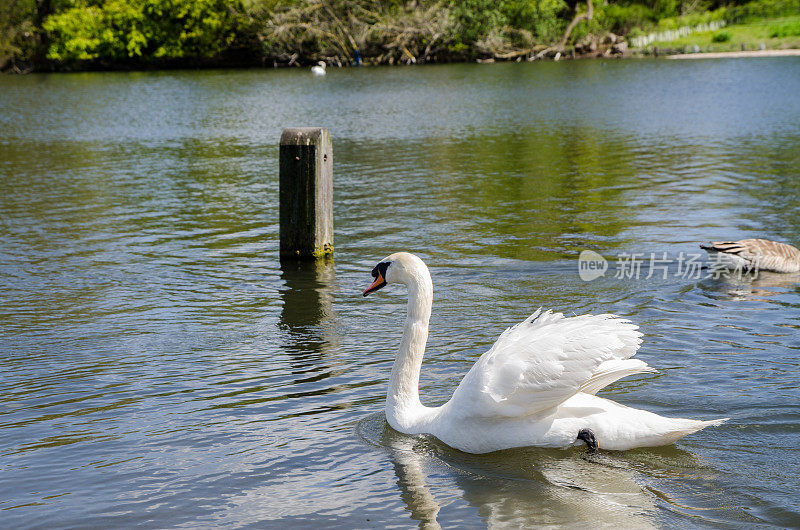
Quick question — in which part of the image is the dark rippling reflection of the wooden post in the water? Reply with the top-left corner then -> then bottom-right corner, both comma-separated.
278,255 -> 336,373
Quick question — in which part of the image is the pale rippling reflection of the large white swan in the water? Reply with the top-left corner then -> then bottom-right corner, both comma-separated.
370,415 -> 716,528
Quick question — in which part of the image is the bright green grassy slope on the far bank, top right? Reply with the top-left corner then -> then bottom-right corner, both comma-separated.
648,15 -> 800,52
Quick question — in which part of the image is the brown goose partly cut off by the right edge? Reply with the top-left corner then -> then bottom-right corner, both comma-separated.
700,239 -> 800,272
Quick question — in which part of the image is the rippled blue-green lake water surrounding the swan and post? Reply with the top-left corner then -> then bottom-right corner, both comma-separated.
0,58 -> 800,528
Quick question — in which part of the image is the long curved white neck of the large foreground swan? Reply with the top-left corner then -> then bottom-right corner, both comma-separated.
386,265 -> 433,432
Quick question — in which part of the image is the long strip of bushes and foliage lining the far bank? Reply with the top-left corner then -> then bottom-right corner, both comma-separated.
0,0 -> 800,70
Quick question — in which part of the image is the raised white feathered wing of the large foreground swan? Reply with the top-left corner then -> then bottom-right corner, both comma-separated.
450,310 -> 654,417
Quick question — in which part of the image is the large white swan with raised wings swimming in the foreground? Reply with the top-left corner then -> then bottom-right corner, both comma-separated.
364,252 -> 727,453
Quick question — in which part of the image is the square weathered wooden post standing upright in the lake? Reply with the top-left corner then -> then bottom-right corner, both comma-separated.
280,127 -> 333,259
